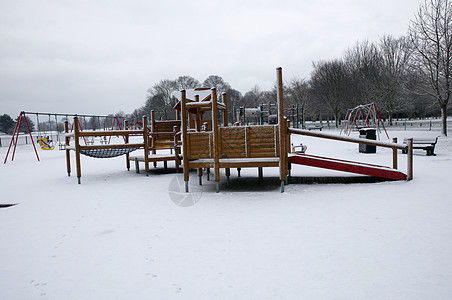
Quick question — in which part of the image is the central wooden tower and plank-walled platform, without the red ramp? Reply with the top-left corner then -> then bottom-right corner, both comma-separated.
180,68 -> 289,192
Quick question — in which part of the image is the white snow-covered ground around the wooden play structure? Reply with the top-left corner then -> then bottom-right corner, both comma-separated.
0,131 -> 452,300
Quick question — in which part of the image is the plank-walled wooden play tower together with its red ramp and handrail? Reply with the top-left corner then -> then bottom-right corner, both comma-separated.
178,68 -> 413,192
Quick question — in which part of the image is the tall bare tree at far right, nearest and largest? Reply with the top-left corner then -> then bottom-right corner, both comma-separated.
409,0 -> 452,135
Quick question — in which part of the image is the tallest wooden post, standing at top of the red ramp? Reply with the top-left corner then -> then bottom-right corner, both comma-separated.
276,67 -> 286,193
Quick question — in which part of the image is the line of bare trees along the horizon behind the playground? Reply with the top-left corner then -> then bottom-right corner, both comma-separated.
0,0 -> 452,135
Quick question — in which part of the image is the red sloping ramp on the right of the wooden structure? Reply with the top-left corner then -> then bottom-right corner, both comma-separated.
289,154 -> 407,180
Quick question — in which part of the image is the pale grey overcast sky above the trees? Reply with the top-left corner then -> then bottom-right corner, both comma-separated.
0,0 -> 420,117
